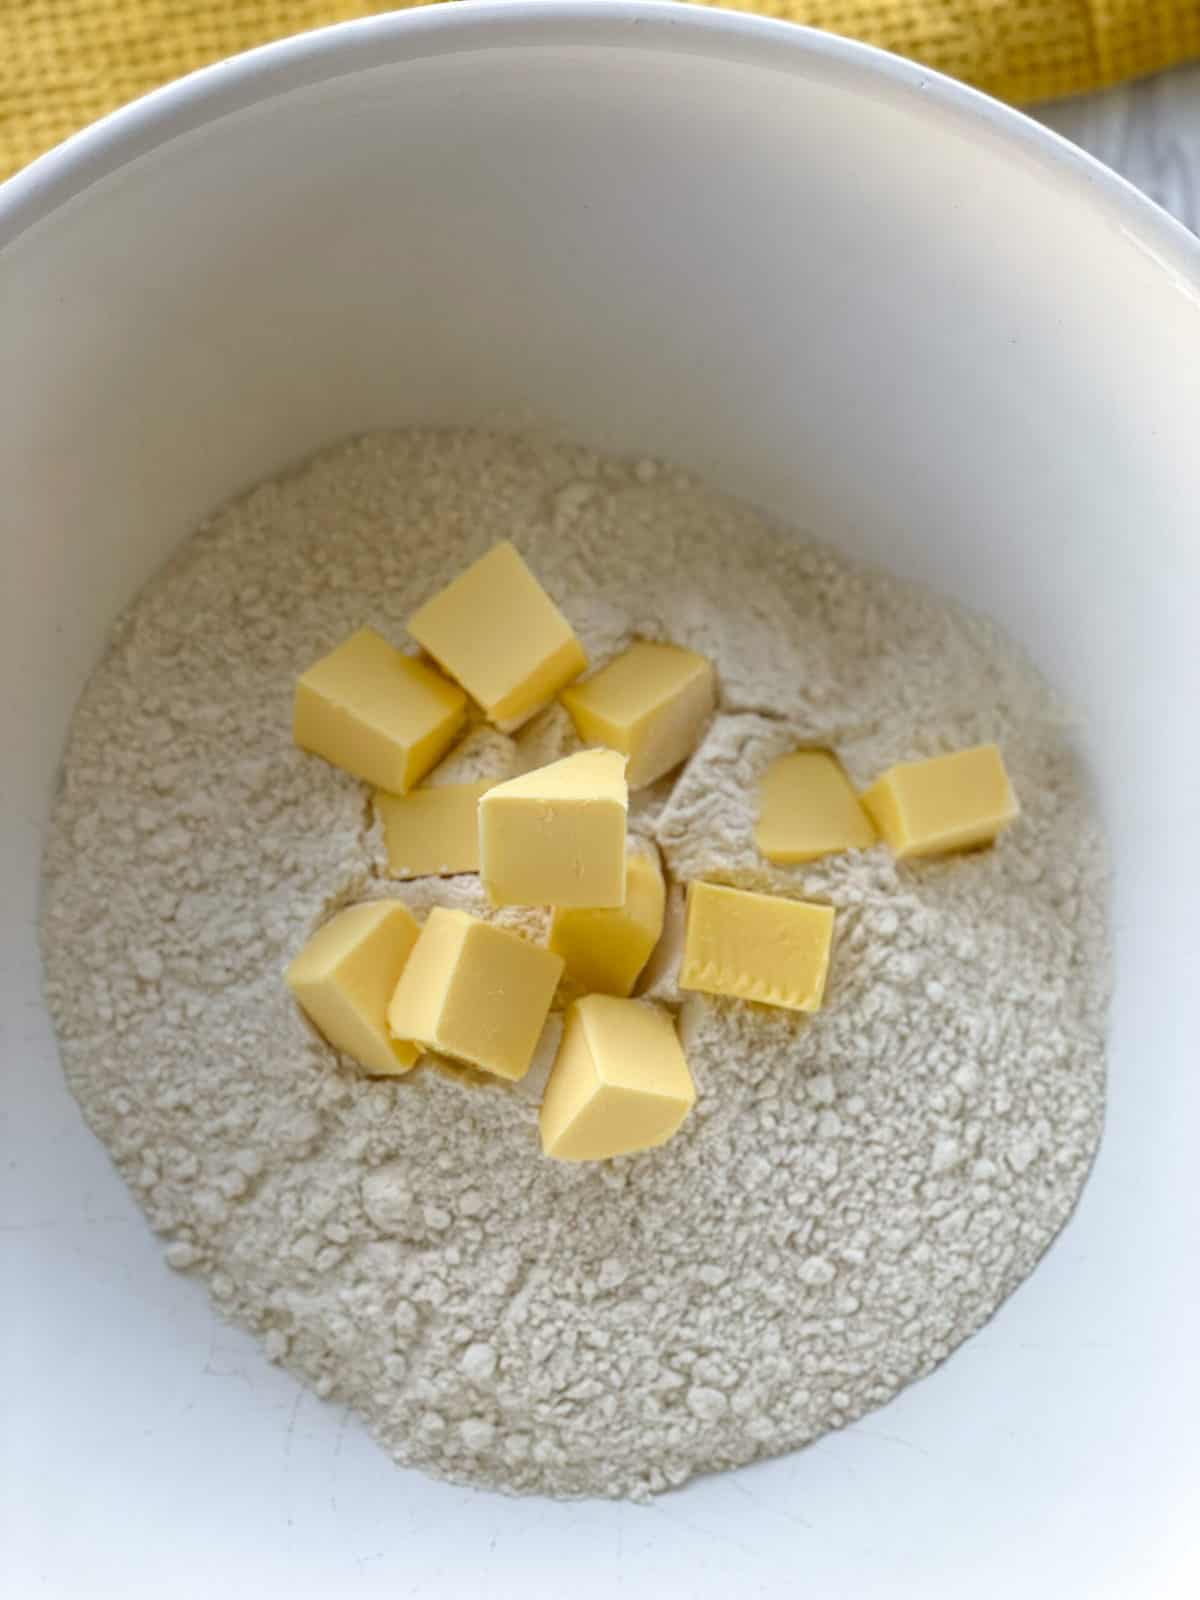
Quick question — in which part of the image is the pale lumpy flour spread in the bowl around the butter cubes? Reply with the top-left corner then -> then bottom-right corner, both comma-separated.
43,432 -> 1109,1498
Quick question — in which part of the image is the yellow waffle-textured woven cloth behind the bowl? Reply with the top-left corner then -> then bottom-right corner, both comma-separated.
0,0 -> 1200,178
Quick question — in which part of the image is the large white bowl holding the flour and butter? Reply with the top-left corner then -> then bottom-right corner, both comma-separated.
0,3 -> 1200,1600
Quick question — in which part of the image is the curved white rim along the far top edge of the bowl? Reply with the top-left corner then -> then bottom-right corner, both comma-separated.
0,0 -> 1200,291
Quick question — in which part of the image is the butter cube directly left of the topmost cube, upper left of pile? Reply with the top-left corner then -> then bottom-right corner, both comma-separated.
291,627 -> 467,795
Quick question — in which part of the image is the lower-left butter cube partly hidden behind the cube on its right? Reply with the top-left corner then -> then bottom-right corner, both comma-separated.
286,901 -> 421,1077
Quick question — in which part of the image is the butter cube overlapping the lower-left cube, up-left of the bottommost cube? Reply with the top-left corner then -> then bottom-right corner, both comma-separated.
387,906 -> 563,1082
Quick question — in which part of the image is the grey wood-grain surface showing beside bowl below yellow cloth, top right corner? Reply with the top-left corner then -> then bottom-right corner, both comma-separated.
1034,64 -> 1200,234
